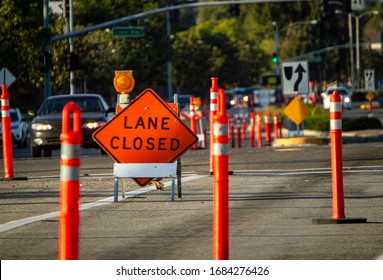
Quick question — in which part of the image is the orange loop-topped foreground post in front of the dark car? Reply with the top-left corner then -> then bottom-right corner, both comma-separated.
58,102 -> 82,260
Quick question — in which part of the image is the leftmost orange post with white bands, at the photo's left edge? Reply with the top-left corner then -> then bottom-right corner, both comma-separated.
1,84 -> 13,179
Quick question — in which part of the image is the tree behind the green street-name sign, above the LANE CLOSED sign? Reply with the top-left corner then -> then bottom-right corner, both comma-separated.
56,0 -> 170,99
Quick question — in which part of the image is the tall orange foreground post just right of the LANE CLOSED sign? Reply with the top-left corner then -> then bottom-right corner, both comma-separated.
213,89 -> 229,260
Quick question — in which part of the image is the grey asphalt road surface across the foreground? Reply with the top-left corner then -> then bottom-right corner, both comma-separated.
0,141 -> 383,260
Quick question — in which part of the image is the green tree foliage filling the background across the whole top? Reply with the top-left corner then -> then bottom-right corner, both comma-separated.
0,0 -> 383,112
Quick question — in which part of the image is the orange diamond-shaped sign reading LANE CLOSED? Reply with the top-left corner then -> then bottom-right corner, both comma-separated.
93,89 -> 198,186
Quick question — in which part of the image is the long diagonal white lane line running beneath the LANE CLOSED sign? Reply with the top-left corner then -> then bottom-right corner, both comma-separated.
0,175 -> 208,233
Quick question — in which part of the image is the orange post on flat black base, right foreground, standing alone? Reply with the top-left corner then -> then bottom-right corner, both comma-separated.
313,91 -> 367,224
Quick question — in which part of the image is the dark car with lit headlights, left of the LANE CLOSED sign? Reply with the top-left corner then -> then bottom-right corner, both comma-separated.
30,94 -> 114,158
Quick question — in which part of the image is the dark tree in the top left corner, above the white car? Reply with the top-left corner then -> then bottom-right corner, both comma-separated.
0,0 -> 49,111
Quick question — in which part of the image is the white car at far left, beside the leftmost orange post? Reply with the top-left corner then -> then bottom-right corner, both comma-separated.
0,108 -> 29,148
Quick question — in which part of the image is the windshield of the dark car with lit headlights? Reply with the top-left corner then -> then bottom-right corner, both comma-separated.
38,96 -> 105,115
